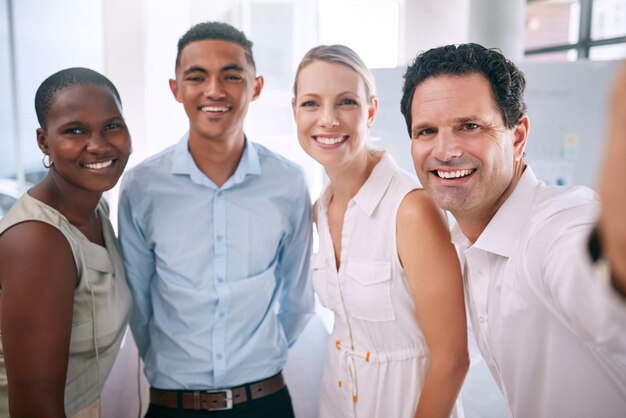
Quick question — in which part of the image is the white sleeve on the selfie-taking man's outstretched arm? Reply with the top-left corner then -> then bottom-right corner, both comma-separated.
527,205 -> 626,364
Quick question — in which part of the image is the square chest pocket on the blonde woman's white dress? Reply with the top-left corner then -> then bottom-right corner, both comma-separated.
345,260 -> 395,322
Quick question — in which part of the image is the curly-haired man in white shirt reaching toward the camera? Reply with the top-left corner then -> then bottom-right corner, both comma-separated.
401,44 -> 626,418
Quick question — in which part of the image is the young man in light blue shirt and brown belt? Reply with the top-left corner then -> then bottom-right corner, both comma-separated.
119,22 -> 314,417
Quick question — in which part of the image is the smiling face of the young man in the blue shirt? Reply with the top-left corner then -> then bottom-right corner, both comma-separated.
170,40 -> 263,146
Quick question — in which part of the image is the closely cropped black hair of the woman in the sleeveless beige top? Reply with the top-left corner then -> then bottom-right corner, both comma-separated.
35,67 -> 122,129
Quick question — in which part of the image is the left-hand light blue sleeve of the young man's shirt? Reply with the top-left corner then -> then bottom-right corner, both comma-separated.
118,171 -> 155,358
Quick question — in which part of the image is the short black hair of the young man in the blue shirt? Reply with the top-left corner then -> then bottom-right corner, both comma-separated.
176,22 -> 256,69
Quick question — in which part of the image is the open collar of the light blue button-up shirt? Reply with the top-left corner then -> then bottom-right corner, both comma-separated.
172,132 -> 262,188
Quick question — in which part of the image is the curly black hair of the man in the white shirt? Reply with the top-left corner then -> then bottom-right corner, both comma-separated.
400,43 -> 526,136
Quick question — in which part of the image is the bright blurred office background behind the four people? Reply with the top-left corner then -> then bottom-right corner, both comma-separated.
0,0 -> 626,418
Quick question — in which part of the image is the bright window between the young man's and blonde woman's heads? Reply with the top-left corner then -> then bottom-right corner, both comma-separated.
229,0 -> 403,198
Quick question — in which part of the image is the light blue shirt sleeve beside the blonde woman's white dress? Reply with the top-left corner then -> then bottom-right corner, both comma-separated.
278,169 -> 315,347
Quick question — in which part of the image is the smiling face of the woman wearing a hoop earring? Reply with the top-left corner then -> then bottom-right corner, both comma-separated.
37,84 -> 131,192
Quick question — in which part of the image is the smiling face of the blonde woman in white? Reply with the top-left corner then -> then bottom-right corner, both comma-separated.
292,60 -> 378,168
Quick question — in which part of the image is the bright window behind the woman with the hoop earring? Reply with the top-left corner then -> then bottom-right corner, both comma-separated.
0,0 -> 104,182
